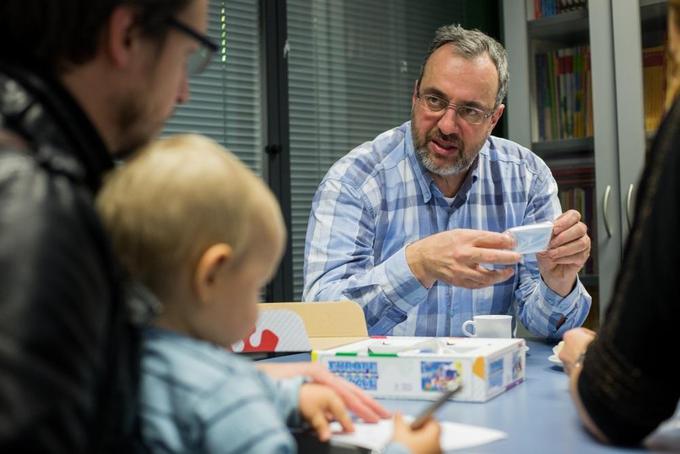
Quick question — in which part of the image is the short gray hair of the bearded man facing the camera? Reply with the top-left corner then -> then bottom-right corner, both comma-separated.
418,25 -> 510,108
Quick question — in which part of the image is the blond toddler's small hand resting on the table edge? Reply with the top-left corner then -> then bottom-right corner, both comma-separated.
299,383 -> 354,441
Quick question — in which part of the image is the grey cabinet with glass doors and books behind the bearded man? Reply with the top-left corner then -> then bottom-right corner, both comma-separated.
503,0 -> 666,327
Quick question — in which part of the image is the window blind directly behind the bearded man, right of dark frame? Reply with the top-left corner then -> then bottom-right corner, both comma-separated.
287,0 -> 464,299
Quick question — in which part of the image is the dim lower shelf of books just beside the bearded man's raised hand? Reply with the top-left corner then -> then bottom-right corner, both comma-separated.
552,166 -> 597,275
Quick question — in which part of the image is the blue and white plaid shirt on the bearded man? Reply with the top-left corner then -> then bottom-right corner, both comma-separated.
303,122 -> 591,338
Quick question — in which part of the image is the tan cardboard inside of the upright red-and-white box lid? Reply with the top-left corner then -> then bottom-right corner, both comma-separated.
259,301 -> 368,338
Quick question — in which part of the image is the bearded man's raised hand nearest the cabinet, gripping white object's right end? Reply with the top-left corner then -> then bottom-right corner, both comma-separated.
536,210 -> 590,296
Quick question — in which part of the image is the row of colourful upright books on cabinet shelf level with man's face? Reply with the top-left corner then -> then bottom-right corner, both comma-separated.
534,46 -> 593,141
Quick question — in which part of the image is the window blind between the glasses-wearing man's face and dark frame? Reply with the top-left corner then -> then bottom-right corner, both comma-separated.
163,0 -> 263,175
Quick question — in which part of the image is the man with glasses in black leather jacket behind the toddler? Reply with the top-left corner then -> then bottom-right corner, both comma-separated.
0,0 -> 214,453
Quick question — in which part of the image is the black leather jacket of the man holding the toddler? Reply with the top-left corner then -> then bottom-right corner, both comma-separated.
0,61 -> 138,453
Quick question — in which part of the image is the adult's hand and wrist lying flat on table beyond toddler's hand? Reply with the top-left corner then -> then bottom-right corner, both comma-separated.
257,363 -> 390,423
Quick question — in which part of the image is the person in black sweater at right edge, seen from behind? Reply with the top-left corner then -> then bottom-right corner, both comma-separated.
559,0 -> 680,445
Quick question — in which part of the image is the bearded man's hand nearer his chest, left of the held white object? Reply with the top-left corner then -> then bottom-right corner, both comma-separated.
406,229 -> 522,289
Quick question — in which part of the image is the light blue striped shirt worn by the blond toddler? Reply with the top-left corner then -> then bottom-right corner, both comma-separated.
140,328 -> 303,454
